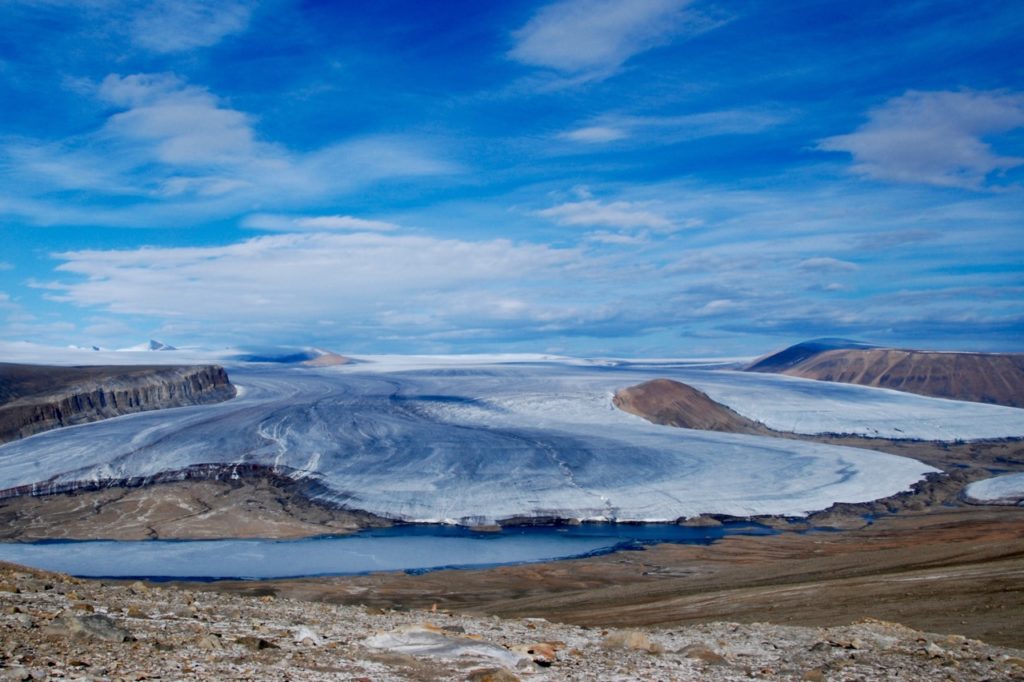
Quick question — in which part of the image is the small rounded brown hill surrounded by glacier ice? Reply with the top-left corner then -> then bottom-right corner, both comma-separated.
611,379 -> 768,434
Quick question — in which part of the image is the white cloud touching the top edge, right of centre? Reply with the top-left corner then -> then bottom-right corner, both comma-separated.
509,0 -> 689,74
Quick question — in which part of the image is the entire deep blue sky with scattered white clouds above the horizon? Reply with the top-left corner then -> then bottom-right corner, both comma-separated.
0,0 -> 1024,356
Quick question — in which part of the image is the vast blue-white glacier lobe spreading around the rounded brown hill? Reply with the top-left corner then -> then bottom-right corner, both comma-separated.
0,353 -> 1024,523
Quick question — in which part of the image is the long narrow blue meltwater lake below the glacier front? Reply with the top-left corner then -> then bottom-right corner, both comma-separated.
0,522 -> 774,581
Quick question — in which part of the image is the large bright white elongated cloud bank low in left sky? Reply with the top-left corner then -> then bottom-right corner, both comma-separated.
44,231 -> 579,330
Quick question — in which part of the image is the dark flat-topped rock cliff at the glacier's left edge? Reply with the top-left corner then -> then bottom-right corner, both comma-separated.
0,364 -> 236,442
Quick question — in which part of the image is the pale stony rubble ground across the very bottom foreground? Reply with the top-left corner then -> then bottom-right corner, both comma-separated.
0,564 -> 1024,681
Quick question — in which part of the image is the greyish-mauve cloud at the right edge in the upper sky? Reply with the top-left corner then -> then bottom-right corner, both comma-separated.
818,90 -> 1024,189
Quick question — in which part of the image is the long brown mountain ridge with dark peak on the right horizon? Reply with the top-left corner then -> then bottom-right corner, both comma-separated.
745,339 -> 1024,408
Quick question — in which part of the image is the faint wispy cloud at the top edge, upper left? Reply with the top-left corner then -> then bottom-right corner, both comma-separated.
130,0 -> 251,52
